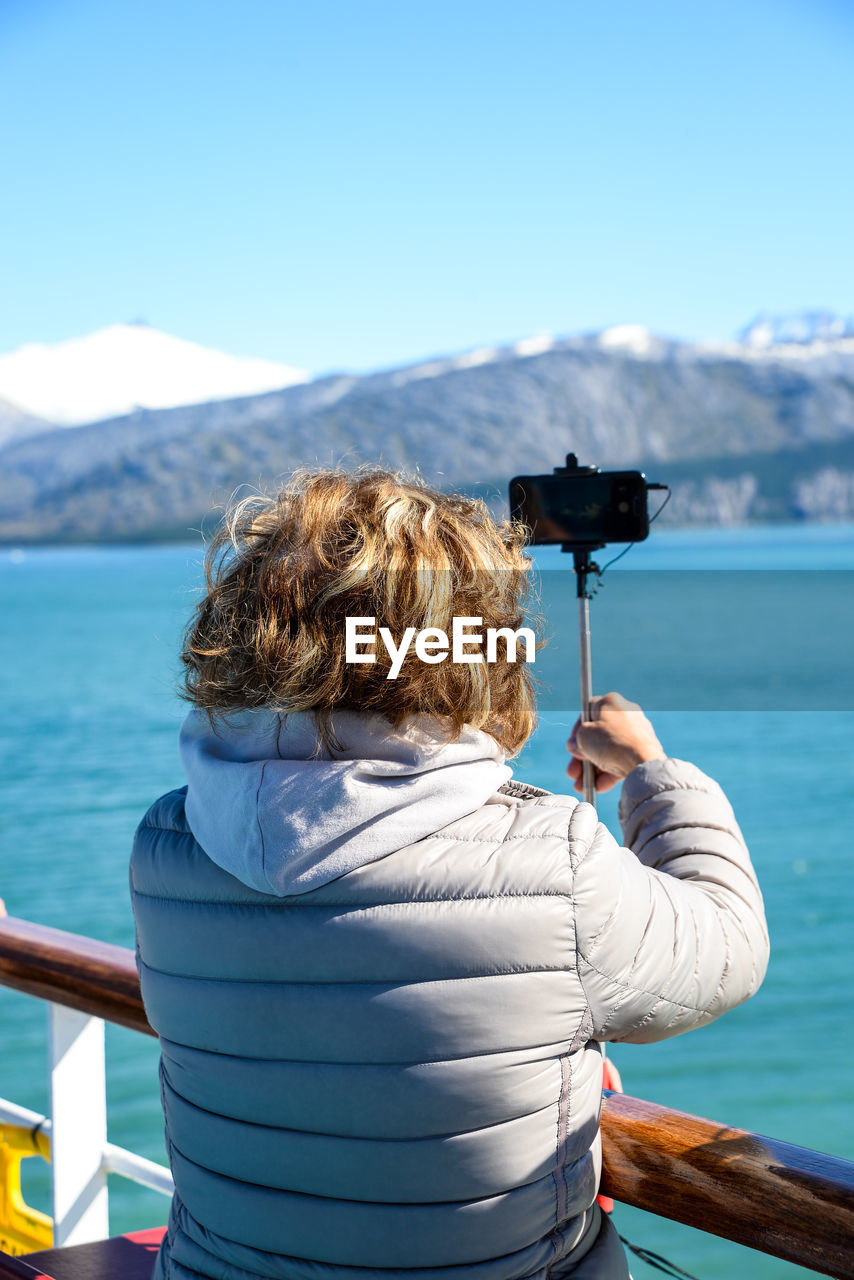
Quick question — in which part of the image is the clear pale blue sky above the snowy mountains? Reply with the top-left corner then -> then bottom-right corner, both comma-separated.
0,0 -> 854,371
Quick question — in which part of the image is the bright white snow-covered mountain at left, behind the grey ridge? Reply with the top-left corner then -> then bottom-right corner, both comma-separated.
0,324 -> 310,426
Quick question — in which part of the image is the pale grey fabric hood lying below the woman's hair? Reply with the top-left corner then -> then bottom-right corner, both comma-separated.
179,710 -> 511,896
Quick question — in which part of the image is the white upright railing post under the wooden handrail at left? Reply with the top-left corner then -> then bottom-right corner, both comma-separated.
49,1004 -> 109,1245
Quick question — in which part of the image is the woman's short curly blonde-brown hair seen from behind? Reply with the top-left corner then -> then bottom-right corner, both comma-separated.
181,470 -> 536,755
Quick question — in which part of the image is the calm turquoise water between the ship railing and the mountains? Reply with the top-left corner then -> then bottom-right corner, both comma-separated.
0,525 -> 854,1280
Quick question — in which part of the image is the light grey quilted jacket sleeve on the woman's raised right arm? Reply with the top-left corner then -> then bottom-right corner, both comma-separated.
570,759 -> 768,1043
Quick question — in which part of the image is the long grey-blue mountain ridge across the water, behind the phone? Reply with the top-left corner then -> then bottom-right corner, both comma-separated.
0,329 -> 854,544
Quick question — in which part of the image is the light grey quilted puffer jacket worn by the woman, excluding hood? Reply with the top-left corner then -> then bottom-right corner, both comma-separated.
131,732 -> 768,1280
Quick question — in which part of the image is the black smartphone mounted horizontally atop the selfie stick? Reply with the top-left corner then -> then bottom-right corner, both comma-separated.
510,453 -> 658,550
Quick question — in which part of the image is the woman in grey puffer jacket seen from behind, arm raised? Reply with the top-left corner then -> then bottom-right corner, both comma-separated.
132,471 -> 767,1280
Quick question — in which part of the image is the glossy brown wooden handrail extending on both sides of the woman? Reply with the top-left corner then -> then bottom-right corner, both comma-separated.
0,916 -> 854,1280
